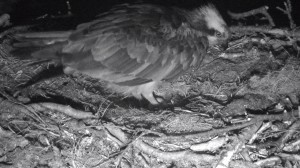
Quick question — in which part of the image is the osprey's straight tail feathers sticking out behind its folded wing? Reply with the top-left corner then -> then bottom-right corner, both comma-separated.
12,31 -> 71,61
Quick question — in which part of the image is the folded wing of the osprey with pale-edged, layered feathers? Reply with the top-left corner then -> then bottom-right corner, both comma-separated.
63,5 -> 207,86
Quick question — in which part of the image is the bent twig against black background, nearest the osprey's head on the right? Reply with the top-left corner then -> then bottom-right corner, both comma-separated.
228,6 -> 275,27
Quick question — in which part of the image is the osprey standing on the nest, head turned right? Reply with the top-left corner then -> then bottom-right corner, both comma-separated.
14,4 -> 230,104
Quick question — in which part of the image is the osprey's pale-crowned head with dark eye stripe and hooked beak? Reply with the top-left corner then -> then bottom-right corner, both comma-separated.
190,4 -> 230,48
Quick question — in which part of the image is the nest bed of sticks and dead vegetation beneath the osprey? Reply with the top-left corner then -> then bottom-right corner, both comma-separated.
0,1 -> 300,168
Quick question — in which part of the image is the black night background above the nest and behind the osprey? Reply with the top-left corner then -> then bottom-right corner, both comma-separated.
0,0 -> 300,27
